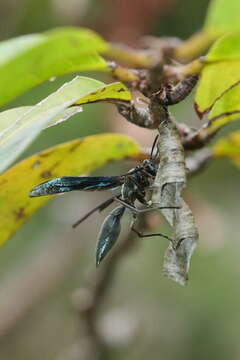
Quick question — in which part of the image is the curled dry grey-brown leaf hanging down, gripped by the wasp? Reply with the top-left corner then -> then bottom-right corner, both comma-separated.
152,117 -> 198,285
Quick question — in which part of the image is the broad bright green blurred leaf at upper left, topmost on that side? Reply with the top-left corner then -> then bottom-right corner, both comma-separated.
0,27 -> 108,106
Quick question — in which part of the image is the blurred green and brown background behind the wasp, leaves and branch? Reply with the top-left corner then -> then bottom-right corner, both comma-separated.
0,0 -> 240,360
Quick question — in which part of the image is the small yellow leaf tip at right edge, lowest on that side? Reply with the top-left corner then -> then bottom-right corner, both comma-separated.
212,131 -> 240,167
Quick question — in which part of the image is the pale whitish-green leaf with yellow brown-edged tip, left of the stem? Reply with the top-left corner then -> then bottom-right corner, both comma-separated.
0,77 -> 131,172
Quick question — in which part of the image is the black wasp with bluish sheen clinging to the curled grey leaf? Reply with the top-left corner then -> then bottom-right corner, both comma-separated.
29,137 -> 175,265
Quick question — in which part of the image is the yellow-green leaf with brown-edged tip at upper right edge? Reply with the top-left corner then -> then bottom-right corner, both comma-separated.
195,33 -> 240,117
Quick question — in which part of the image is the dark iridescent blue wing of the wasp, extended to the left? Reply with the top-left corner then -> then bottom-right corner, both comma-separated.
29,176 -> 124,197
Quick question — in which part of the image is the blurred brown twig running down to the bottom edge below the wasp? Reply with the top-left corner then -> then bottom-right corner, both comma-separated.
64,224 -> 140,360
